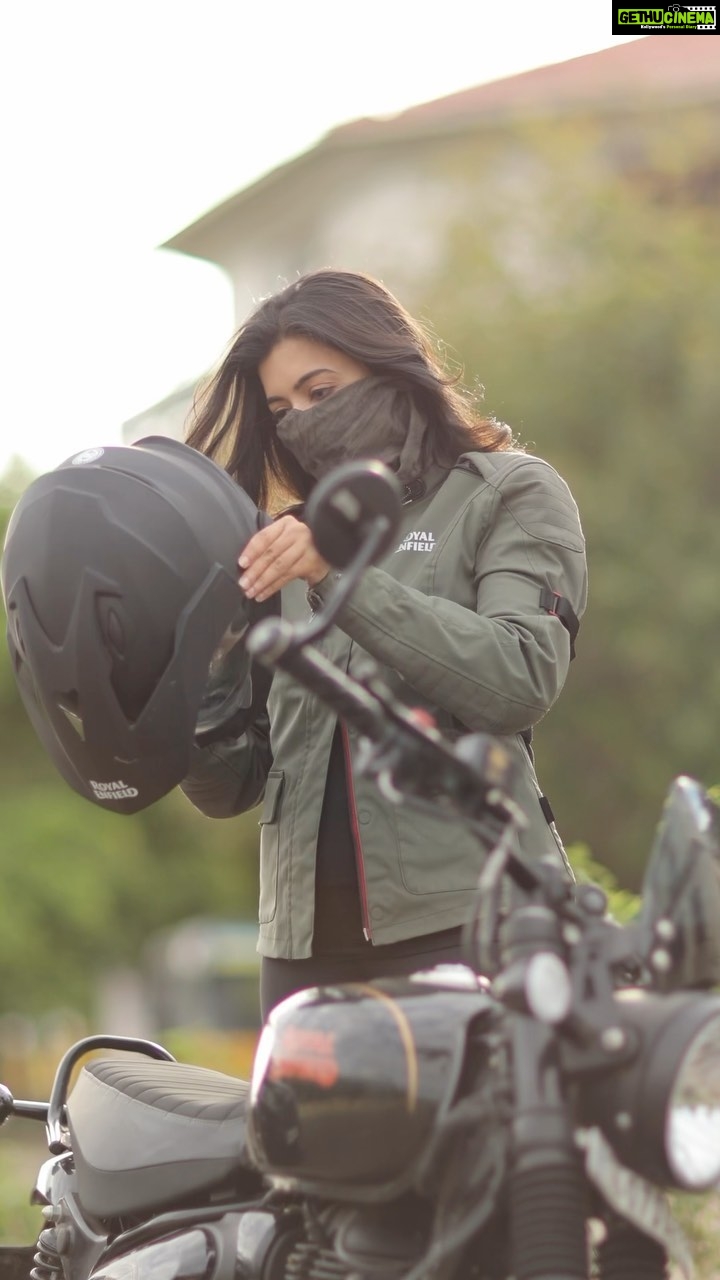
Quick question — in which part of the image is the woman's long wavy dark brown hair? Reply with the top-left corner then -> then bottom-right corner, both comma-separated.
186,269 -> 514,508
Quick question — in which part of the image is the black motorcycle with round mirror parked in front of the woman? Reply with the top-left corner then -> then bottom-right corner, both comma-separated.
0,465 -> 720,1280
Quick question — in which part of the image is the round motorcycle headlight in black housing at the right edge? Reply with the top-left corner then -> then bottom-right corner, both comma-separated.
583,989 -> 720,1192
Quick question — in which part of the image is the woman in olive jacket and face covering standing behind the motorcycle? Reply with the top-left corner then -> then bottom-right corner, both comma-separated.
183,270 -> 587,1016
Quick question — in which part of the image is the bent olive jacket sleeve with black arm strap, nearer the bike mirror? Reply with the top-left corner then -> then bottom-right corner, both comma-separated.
316,454 -> 587,733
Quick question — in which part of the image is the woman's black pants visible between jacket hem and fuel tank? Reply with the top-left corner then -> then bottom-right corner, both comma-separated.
260,928 -> 464,1021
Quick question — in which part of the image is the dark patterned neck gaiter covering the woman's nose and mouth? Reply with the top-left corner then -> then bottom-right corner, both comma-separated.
271,376 -> 428,484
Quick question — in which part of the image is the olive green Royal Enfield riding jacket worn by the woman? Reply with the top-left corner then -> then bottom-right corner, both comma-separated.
182,451 -> 587,959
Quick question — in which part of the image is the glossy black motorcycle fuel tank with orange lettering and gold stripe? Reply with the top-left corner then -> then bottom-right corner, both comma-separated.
243,965 -> 489,1199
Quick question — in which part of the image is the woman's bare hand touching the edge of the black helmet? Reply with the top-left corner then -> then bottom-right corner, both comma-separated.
237,516 -> 331,600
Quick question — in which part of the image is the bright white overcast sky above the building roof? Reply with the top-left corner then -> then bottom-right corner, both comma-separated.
0,0 -> 638,472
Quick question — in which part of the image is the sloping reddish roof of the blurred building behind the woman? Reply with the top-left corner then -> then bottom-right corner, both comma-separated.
164,36 -> 720,252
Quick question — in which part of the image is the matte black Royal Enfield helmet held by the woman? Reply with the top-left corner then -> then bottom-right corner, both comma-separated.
1,436 -> 275,813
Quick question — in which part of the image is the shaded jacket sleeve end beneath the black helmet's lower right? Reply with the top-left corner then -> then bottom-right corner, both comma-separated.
181,713 -> 273,818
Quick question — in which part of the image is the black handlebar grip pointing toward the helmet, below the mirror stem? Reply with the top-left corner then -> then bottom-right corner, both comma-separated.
245,618 -> 384,741
